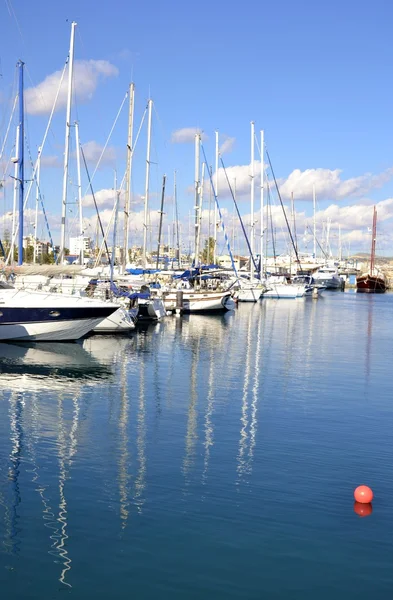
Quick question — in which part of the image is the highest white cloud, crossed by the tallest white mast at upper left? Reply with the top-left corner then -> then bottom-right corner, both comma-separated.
25,60 -> 118,115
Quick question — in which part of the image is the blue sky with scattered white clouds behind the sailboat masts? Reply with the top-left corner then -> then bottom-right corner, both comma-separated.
0,0 -> 393,255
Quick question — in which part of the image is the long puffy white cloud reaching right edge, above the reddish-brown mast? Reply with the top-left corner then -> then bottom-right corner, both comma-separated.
278,168 -> 393,200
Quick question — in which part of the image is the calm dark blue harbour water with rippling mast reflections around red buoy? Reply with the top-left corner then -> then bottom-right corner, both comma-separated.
0,293 -> 393,600
